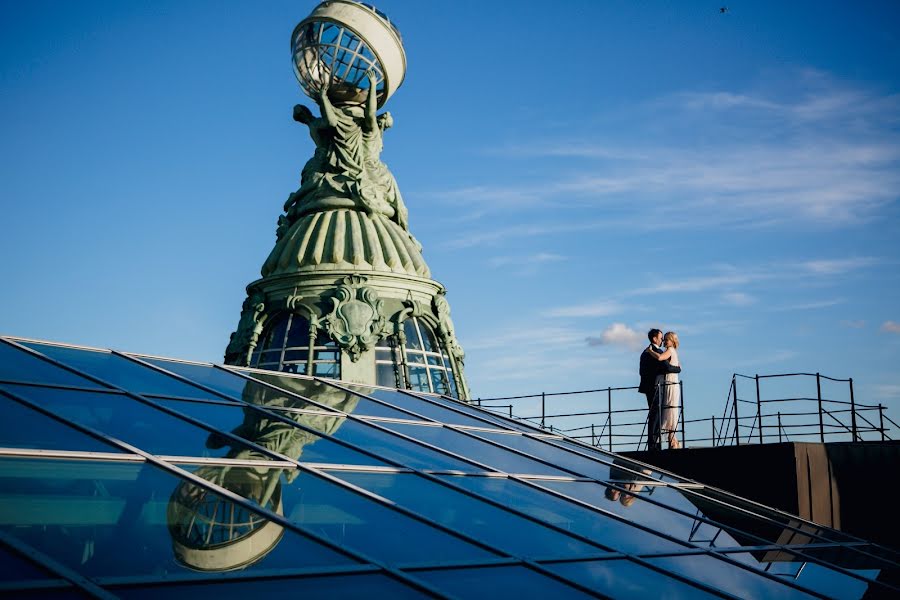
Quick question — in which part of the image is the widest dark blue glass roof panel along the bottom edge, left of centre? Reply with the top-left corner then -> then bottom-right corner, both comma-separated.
113,573 -> 422,600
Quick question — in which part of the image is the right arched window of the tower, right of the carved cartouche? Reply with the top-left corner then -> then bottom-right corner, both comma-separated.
375,317 -> 459,398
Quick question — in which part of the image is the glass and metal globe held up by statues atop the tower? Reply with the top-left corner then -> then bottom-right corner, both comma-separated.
291,0 -> 406,107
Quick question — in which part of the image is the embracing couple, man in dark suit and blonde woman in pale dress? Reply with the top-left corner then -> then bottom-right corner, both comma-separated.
638,329 -> 681,450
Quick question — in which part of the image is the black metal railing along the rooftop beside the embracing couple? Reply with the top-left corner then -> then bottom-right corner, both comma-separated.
475,373 -> 900,452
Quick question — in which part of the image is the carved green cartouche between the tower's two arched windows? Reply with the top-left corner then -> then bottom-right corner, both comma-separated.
325,275 -> 385,362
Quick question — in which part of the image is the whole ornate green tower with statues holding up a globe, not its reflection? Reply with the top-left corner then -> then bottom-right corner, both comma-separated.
225,0 -> 469,400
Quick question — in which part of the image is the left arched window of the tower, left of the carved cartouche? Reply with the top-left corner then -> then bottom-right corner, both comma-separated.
250,313 -> 341,379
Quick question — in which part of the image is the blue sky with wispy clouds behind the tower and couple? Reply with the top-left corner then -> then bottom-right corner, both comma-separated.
0,0 -> 900,432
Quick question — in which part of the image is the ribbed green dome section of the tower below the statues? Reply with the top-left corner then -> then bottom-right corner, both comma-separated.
262,209 -> 431,277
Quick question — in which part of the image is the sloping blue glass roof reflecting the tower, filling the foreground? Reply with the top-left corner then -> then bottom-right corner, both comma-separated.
0,338 -> 900,598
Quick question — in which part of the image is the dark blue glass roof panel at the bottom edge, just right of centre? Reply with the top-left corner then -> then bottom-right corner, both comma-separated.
410,566 -> 594,600
